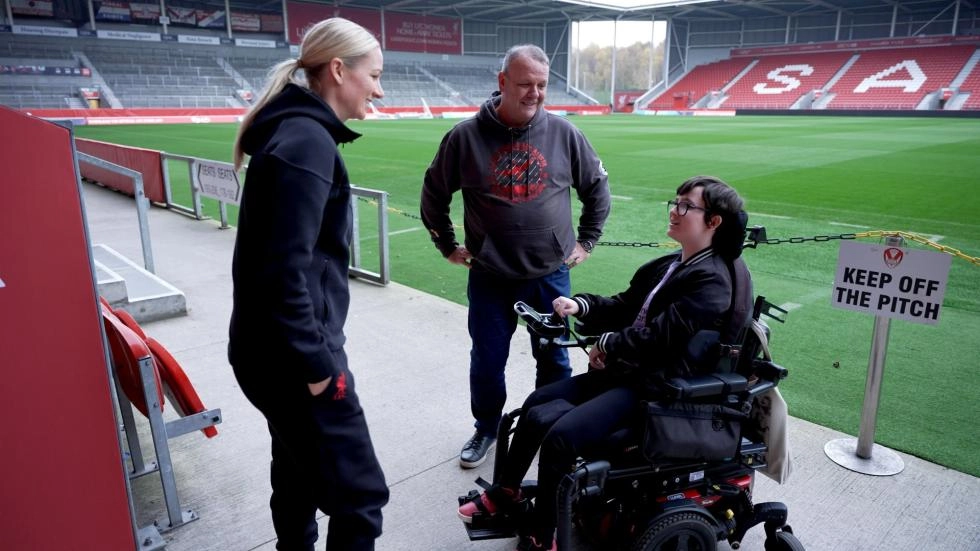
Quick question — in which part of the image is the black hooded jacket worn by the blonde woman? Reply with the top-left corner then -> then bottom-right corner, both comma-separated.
228,84 -> 360,383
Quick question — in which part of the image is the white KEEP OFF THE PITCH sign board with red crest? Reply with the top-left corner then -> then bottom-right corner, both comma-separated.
830,241 -> 952,325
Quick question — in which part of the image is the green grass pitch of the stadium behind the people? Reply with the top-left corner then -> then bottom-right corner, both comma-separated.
76,116 -> 980,476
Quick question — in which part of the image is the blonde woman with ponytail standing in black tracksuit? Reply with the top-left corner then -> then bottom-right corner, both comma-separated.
228,18 -> 388,551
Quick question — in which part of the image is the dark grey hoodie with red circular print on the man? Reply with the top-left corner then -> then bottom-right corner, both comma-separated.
421,92 -> 610,279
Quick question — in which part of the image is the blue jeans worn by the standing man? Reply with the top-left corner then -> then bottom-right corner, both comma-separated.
466,264 -> 572,435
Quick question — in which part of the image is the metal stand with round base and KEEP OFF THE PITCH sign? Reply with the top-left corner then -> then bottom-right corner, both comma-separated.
824,236 -> 950,476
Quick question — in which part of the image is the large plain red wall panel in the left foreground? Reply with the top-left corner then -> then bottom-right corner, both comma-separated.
0,107 -> 136,551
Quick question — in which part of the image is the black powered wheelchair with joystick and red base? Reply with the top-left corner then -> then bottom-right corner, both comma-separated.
459,230 -> 804,551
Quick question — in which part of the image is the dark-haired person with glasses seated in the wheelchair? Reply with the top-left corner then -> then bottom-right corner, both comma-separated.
458,176 -> 752,550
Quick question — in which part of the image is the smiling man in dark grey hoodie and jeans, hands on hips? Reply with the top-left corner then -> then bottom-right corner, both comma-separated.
421,44 -> 610,468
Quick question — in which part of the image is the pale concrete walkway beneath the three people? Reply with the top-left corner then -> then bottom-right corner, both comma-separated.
83,184 -> 980,551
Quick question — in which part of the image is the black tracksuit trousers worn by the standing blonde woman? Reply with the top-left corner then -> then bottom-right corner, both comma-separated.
235,365 -> 388,551
